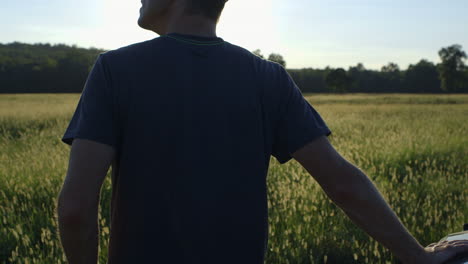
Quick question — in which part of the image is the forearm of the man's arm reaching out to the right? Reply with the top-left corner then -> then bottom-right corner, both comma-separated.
330,164 -> 424,263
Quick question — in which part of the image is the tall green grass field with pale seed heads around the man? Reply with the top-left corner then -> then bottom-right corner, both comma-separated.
0,94 -> 468,264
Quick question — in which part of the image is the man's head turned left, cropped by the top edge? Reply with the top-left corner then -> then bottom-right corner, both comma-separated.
138,0 -> 227,35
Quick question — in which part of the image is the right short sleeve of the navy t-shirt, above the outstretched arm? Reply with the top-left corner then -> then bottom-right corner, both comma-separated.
271,66 -> 331,164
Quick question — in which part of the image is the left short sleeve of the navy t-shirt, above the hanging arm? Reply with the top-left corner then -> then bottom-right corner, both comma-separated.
61,54 -> 117,147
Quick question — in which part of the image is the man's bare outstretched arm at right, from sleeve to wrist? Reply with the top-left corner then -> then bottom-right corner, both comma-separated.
292,136 -> 428,263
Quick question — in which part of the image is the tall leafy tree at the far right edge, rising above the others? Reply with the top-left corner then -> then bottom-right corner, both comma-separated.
438,44 -> 467,92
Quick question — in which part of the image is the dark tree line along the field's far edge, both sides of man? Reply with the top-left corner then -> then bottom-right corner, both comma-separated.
0,42 -> 468,93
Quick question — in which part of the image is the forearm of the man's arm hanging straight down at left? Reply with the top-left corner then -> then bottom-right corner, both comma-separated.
58,200 -> 99,264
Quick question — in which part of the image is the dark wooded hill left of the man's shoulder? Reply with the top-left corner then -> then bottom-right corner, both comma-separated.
0,42 -> 104,93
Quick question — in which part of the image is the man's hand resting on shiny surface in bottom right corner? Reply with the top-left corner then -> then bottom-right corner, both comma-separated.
418,240 -> 468,264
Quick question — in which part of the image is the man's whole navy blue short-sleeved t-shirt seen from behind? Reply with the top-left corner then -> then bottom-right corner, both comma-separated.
62,33 -> 331,264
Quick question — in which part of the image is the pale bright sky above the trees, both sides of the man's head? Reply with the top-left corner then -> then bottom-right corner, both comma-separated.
0,0 -> 468,69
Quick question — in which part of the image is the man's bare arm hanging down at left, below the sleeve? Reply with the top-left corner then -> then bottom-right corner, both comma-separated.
57,138 -> 115,264
